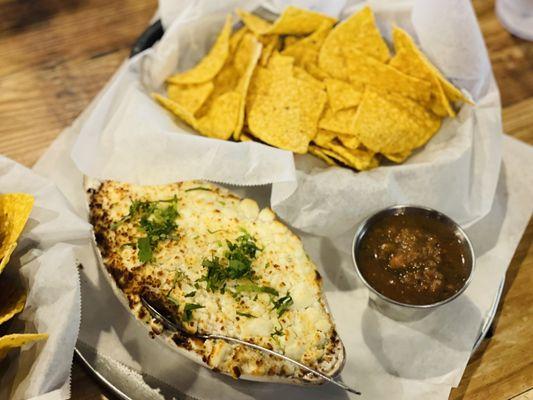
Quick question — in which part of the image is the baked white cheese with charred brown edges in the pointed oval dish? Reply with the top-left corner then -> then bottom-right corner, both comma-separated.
86,180 -> 344,383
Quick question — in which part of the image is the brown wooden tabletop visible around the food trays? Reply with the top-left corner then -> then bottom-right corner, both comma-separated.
0,0 -> 533,400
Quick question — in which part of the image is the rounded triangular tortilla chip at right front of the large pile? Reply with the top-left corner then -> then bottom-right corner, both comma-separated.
354,89 -> 441,154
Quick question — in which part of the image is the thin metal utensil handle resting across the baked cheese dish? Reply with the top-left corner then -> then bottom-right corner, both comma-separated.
141,296 -> 361,395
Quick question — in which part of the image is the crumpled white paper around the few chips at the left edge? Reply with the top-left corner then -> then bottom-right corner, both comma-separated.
0,156 -> 90,400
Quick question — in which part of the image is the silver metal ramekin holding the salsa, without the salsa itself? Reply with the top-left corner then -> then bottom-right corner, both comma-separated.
352,205 -> 475,321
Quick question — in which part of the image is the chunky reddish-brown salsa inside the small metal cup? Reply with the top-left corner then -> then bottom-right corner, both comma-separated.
356,211 -> 472,305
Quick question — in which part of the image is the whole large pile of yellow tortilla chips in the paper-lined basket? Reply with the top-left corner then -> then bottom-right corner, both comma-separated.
153,6 -> 470,170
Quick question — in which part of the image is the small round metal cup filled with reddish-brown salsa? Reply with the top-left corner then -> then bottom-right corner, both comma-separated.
352,205 -> 475,320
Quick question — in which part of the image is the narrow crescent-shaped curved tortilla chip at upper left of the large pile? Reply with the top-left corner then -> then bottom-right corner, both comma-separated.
167,16 -> 231,84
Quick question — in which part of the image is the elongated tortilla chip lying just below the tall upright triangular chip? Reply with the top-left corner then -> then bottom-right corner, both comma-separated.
320,48 -> 431,102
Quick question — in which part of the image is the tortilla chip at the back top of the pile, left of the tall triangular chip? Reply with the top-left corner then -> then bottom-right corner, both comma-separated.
268,6 -> 337,35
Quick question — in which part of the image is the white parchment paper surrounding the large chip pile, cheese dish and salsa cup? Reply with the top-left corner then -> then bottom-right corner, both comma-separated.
30,0 -> 533,399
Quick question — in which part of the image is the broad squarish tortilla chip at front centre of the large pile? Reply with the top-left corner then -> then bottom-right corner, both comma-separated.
248,59 -> 326,154
